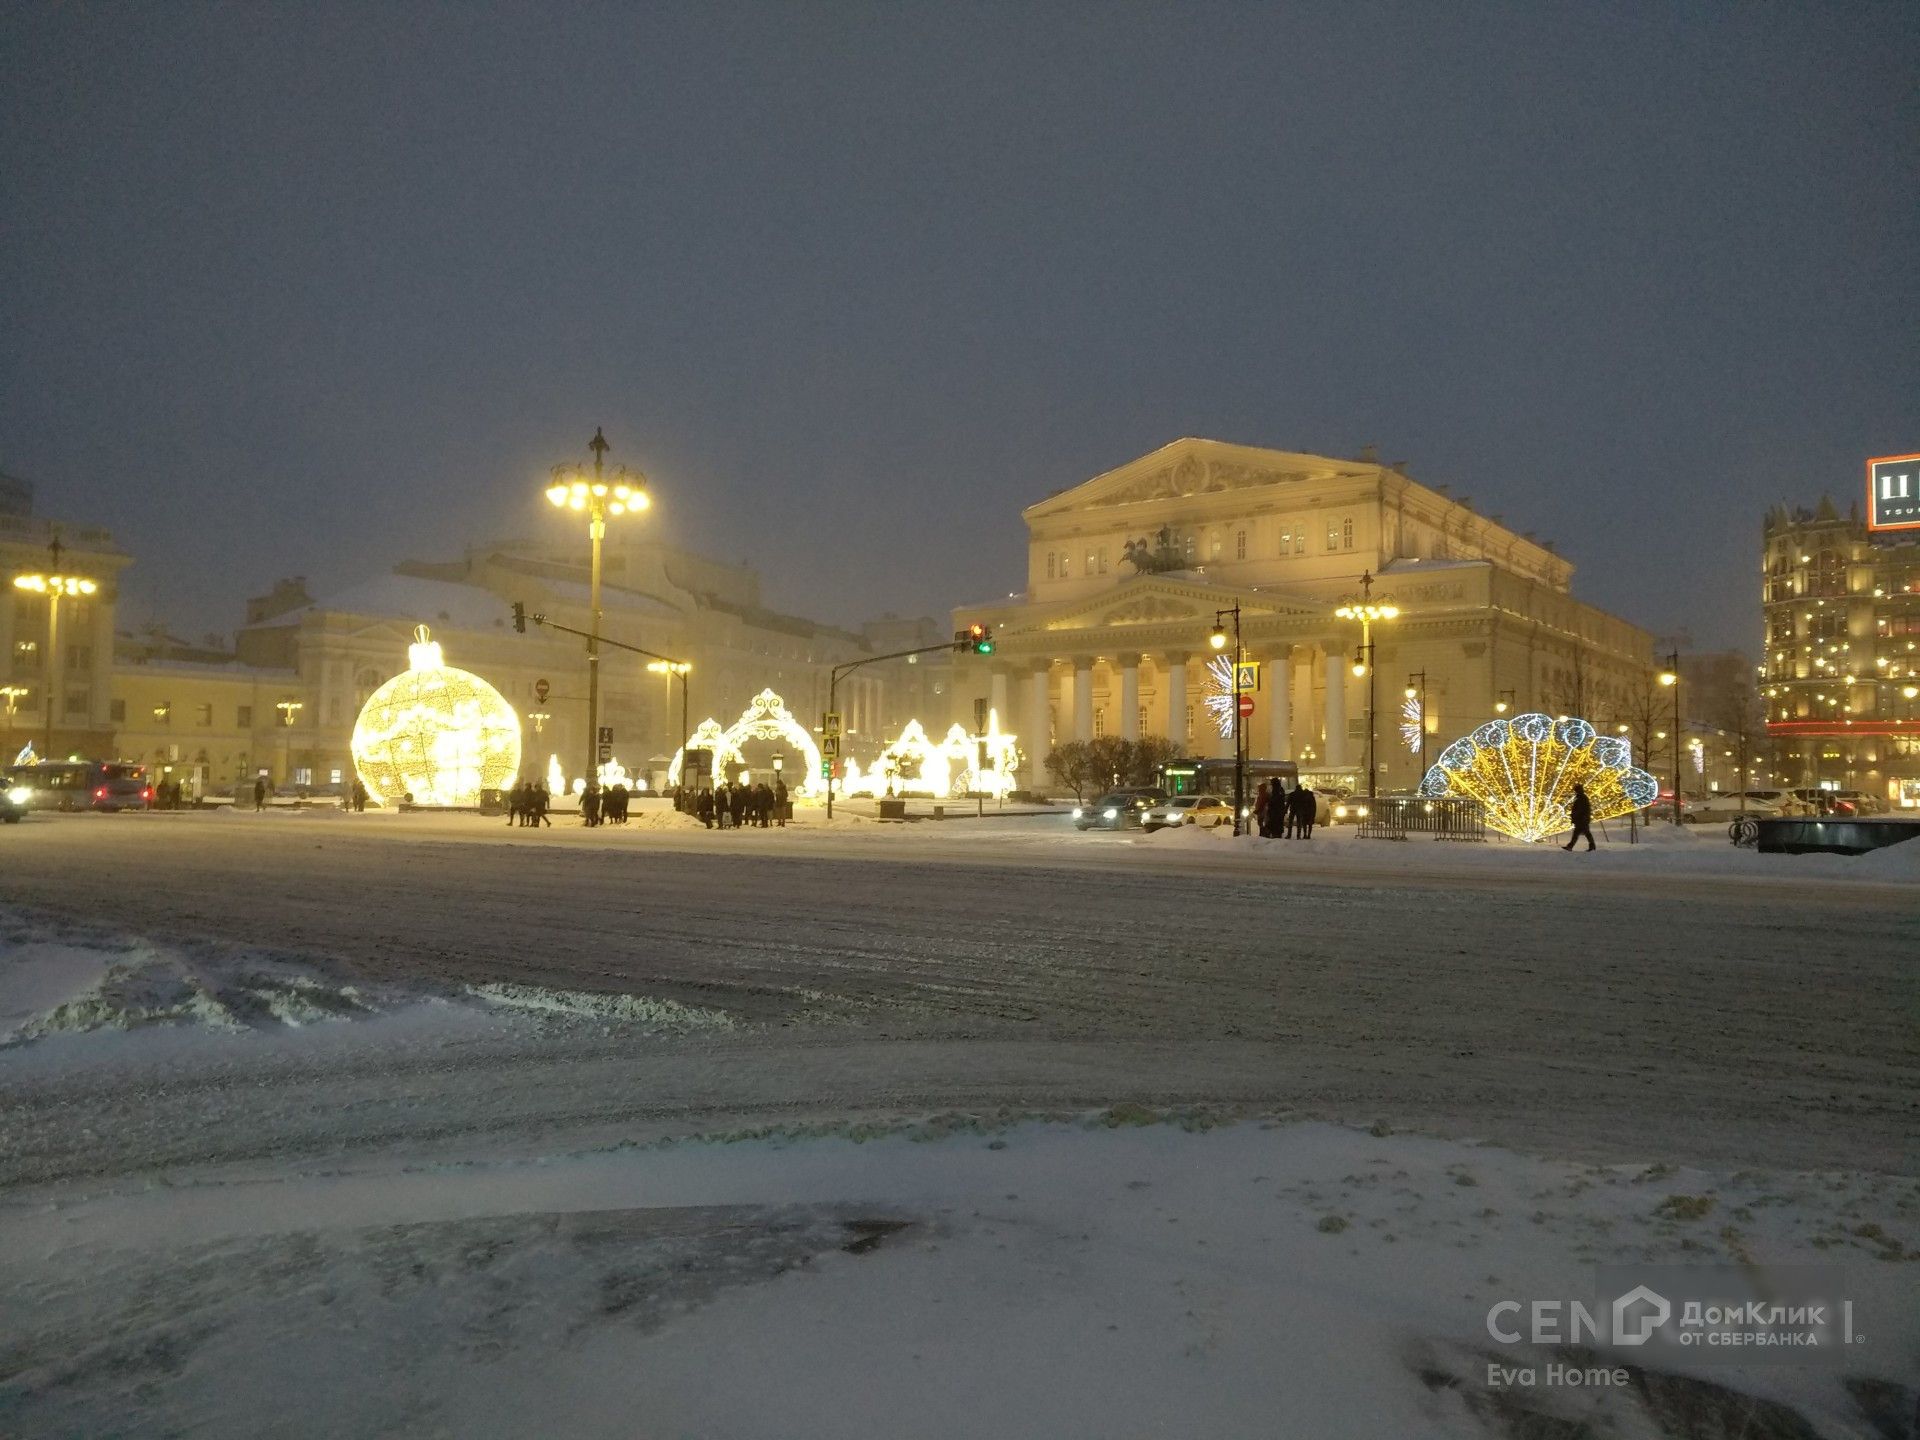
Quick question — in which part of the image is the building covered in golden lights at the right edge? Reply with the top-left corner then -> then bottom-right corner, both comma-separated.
1761,497 -> 1920,810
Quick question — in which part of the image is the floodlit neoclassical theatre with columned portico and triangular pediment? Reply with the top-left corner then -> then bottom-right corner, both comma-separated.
954,440 -> 1653,802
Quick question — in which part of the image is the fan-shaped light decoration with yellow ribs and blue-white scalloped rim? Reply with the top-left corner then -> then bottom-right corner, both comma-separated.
1421,714 -> 1661,841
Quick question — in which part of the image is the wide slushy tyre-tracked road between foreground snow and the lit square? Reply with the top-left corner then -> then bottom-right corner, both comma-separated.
0,812 -> 1920,1188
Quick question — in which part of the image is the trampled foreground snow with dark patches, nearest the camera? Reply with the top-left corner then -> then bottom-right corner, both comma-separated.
0,1108 -> 1920,1440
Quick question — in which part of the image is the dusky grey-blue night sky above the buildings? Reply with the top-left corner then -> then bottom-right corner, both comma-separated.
0,0 -> 1920,647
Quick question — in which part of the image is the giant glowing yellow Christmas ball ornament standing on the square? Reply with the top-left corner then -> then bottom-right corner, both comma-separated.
353,626 -> 520,804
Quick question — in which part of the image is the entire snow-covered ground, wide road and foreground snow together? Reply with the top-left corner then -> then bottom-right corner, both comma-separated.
0,812 -> 1920,1438
